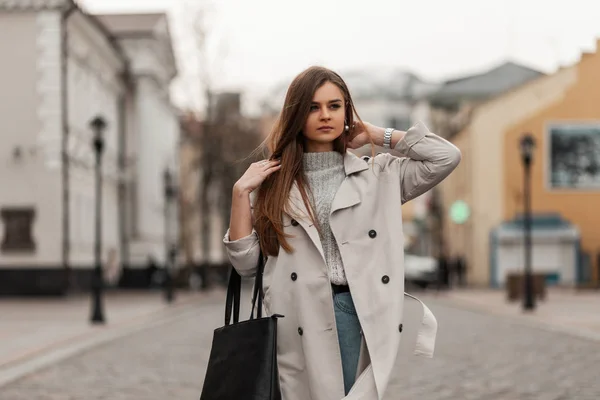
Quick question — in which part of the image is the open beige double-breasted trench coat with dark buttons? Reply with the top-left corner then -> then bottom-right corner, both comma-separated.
224,123 -> 461,400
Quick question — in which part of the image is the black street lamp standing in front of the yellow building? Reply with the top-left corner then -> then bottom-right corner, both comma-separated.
520,133 -> 535,311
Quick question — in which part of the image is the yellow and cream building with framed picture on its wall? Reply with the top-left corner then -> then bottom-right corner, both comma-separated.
441,41 -> 600,286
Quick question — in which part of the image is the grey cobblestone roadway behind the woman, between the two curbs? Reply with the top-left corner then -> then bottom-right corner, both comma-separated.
0,290 -> 600,400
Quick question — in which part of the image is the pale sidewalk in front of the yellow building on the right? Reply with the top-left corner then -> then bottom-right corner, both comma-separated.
430,288 -> 600,341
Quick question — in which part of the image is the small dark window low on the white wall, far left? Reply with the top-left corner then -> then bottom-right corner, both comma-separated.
0,208 -> 35,251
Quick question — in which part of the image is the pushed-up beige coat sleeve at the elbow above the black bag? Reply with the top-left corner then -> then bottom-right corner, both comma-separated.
223,190 -> 260,277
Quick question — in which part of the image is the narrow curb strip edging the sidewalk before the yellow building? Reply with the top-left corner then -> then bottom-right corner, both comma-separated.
431,296 -> 600,342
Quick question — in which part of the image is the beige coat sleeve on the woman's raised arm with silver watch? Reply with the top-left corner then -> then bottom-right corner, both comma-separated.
386,122 -> 462,204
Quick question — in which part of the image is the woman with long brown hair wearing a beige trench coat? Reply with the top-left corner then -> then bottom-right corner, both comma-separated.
224,67 -> 461,400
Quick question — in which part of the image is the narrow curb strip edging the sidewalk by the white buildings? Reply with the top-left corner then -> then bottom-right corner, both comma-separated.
0,296 -> 220,388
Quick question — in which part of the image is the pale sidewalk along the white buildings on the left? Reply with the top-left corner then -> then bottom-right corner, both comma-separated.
0,288 -> 225,386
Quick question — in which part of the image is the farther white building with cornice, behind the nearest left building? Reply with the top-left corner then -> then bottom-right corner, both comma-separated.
97,14 -> 180,286
